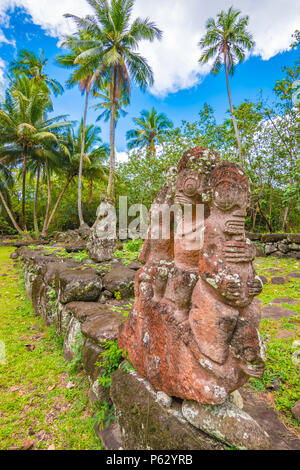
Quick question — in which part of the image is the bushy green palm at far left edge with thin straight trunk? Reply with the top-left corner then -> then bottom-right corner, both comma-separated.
0,75 -> 69,231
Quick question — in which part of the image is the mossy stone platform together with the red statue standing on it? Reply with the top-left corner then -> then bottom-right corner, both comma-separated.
13,147 -> 300,450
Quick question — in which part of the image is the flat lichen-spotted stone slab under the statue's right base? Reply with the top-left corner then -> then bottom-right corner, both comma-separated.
182,400 -> 270,450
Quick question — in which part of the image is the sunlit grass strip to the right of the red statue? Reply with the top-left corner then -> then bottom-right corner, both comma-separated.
250,257 -> 300,432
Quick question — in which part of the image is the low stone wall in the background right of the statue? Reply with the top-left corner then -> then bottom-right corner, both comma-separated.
246,233 -> 300,259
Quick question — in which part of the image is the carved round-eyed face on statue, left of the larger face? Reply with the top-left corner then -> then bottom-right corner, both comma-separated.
175,169 -> 203,205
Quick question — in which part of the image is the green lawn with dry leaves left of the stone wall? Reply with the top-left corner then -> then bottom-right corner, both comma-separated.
0,247 -> 101,449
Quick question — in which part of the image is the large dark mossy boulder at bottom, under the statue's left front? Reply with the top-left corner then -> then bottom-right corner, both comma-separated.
110,368 -> 224,450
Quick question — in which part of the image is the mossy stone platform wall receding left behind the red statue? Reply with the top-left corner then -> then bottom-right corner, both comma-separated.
17,247 -> 139,401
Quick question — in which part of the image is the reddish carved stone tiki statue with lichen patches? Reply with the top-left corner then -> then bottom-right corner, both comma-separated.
119,147 -> 264,404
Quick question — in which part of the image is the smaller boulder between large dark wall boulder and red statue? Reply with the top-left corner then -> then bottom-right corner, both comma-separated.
103,266 -> 135,299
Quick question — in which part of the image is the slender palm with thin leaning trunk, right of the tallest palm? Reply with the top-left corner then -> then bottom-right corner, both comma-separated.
199,7 -> 255,163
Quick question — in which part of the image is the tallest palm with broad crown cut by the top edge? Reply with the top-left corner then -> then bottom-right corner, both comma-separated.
65,0 -> 162,200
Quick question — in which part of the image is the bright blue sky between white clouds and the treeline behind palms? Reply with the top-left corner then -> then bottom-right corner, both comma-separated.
0,0 -> 300,158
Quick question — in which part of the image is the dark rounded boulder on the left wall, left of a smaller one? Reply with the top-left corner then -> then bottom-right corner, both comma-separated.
55,267 -> 102,304
